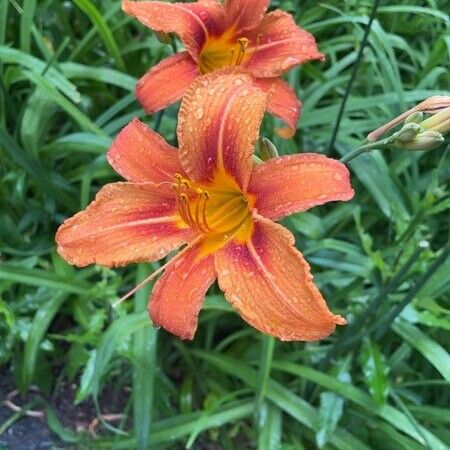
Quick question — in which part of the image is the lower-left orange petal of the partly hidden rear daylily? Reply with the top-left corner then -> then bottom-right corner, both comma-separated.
136,52 -> 200,114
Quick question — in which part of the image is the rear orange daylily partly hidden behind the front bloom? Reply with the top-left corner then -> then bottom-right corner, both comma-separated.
122,0 -> 324,138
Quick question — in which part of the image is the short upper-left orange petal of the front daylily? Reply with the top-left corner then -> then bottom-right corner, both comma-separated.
106,119 -> 183,184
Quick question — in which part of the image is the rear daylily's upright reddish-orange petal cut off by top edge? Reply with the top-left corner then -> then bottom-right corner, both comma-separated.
224,0 -> 270,30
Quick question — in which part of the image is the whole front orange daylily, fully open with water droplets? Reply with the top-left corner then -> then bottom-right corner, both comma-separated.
56,69 -> 354,341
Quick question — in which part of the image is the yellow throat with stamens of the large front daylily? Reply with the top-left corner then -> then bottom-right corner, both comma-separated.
173,172 -> 254,253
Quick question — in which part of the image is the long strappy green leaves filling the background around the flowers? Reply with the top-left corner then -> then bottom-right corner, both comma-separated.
0,0 -> 450,450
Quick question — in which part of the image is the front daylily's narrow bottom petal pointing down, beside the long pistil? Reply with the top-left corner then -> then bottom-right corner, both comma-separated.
149,246 -> 216,339
